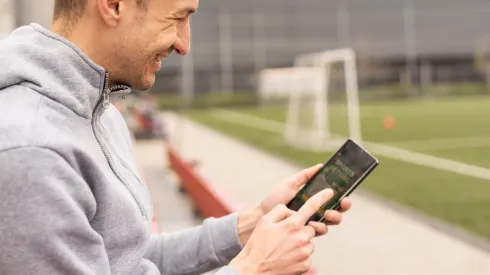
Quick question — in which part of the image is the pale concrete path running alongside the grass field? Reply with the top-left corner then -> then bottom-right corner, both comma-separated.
164,114 -> 490,275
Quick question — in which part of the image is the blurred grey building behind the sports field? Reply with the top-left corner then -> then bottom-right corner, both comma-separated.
154,0 -> 490,97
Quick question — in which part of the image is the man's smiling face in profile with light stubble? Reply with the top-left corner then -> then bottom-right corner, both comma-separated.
111,0 -> 199,90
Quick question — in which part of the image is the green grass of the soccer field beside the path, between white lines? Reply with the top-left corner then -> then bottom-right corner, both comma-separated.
182,96 -> 490,242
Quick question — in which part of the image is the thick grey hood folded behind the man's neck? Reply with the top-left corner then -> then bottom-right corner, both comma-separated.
0,24 -> 129,118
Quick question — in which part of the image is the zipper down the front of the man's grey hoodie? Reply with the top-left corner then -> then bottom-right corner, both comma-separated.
92,73 -> 149,224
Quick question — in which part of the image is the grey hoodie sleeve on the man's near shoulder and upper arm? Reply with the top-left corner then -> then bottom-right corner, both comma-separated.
0,147 -> 110,275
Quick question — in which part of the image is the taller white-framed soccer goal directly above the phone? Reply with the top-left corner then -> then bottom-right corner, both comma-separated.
285,48 -> 362,150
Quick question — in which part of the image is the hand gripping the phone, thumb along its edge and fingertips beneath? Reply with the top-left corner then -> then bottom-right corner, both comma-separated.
258,164 -> 351,231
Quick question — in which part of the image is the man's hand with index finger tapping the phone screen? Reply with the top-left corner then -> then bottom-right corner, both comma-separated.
230,189 -> 333,275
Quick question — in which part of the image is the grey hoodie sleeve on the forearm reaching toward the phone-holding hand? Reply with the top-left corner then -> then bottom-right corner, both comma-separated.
145,214 -> 242,275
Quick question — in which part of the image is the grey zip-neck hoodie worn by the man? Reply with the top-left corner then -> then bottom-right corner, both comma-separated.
0,24 -> 242,275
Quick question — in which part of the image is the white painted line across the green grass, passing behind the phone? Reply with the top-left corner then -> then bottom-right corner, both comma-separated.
212,110 -> 490,180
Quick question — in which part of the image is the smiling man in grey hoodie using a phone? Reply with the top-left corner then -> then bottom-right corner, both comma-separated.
0,0 -> 350,275
